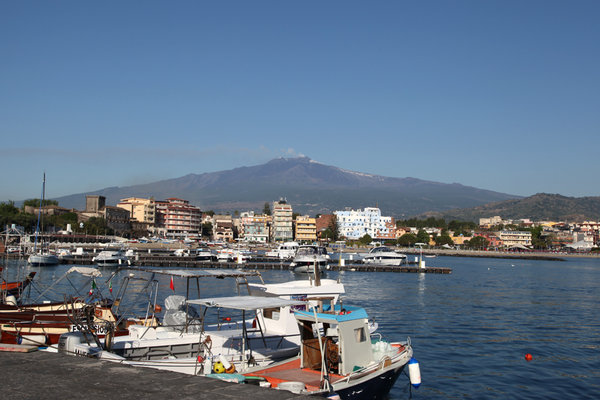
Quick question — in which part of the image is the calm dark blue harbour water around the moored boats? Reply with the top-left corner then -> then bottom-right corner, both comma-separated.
2,257 -> 600,399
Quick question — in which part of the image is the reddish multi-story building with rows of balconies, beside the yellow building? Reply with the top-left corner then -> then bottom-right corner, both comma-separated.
156,197 -> 202,238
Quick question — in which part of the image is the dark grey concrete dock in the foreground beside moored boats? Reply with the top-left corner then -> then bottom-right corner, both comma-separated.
0,351 -> 306,400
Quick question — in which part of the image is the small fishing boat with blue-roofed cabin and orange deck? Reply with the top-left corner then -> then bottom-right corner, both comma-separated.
243,305 -> 418,400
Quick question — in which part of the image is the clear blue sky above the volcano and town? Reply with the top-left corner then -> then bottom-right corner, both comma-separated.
0,0 -> 600,201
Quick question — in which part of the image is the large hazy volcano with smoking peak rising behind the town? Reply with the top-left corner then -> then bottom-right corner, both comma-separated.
55,157 -> 518,218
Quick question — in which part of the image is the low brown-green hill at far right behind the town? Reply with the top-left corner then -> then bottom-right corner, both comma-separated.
427,193 -> 600,222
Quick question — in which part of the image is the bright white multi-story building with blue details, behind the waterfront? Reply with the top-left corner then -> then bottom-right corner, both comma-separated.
334,207 -> 396,240
